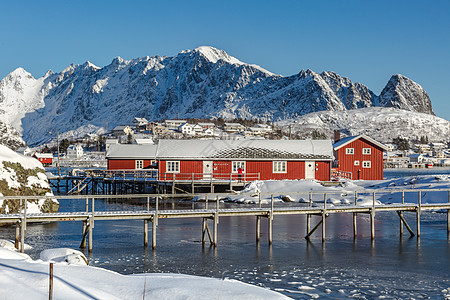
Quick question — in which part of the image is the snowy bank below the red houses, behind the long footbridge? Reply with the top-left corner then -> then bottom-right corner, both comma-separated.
224,175 -> 450,205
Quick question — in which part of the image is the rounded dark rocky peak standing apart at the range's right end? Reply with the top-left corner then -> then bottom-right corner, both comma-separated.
379,74 -> 434,115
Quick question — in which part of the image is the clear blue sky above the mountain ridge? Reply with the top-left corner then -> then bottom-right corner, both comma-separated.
0,0 -> 450,120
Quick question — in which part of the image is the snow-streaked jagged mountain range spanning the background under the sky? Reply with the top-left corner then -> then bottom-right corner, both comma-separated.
0,47 -> 440,145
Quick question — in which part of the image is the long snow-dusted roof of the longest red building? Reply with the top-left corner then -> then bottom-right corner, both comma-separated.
156,140 -> 333,160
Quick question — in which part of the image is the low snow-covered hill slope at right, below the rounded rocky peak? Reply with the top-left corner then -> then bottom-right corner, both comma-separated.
277,107 -> 450,143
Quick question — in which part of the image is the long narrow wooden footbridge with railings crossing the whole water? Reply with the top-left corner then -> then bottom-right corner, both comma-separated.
0,189 -> 450,252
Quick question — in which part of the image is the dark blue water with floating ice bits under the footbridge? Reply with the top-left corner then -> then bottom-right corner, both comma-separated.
0,169 -> 450,299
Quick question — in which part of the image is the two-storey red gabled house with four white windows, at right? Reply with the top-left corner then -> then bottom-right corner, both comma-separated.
333,134 -> 387,180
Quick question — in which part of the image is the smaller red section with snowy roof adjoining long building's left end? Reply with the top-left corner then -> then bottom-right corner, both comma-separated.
106,144 -> 157,170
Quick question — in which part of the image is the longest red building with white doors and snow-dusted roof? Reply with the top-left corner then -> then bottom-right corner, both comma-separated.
156,140 -> 332,181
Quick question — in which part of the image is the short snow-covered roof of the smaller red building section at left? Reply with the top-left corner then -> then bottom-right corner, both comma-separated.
106,144 -> 158,159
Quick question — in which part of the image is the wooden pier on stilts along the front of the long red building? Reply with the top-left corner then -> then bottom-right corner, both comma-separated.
49,170 -> 259,195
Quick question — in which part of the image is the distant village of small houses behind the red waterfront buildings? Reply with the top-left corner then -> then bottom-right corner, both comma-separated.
17,117 -> 450,168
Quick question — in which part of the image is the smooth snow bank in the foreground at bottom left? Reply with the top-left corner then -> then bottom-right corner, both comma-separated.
0,247 -> 289,300
